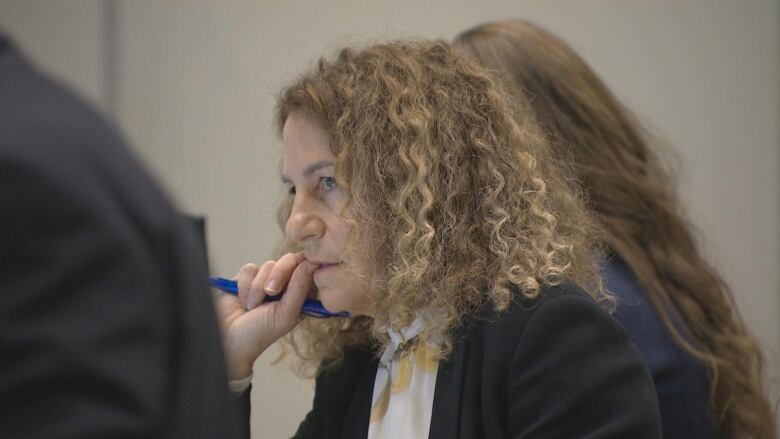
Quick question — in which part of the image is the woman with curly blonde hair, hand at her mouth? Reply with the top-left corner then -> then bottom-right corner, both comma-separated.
219,42 -> 660,438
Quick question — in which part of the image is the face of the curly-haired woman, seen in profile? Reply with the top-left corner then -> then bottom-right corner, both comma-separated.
282,111 -> 370,315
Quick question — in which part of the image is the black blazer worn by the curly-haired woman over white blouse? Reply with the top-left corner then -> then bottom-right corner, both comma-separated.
295,286 -> 661,439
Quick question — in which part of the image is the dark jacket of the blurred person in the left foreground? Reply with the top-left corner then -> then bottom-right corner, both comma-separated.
0,34 -> 248,439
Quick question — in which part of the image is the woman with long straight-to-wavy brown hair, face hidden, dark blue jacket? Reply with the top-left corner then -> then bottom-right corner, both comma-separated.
454,21 -> 774,438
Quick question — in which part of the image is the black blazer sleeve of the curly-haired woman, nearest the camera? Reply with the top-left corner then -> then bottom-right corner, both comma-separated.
507,295 -> 661,438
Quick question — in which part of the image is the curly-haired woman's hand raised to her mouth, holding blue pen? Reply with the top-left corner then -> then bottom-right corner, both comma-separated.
216,252 -> 318,380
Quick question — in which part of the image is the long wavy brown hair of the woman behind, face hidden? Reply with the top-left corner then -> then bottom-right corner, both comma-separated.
454,20 -> 774,438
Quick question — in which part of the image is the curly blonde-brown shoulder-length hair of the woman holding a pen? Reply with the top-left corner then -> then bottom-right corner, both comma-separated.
277,41 -> 610,370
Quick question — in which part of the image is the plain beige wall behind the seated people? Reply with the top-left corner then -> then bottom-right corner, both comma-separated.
0,0 -> 780,438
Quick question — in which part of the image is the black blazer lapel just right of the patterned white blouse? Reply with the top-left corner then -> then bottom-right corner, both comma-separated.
428,339 -> 468,439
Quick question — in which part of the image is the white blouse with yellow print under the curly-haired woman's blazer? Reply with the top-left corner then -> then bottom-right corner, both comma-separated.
368,318 -> 439,439
